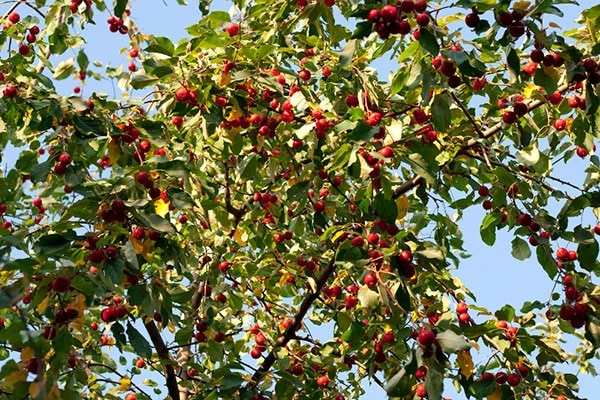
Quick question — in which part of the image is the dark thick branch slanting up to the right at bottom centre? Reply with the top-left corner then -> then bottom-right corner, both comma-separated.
244,258 -> 335,388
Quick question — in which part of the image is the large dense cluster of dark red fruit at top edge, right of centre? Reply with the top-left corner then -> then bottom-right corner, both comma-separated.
367,0 -> 430,39
